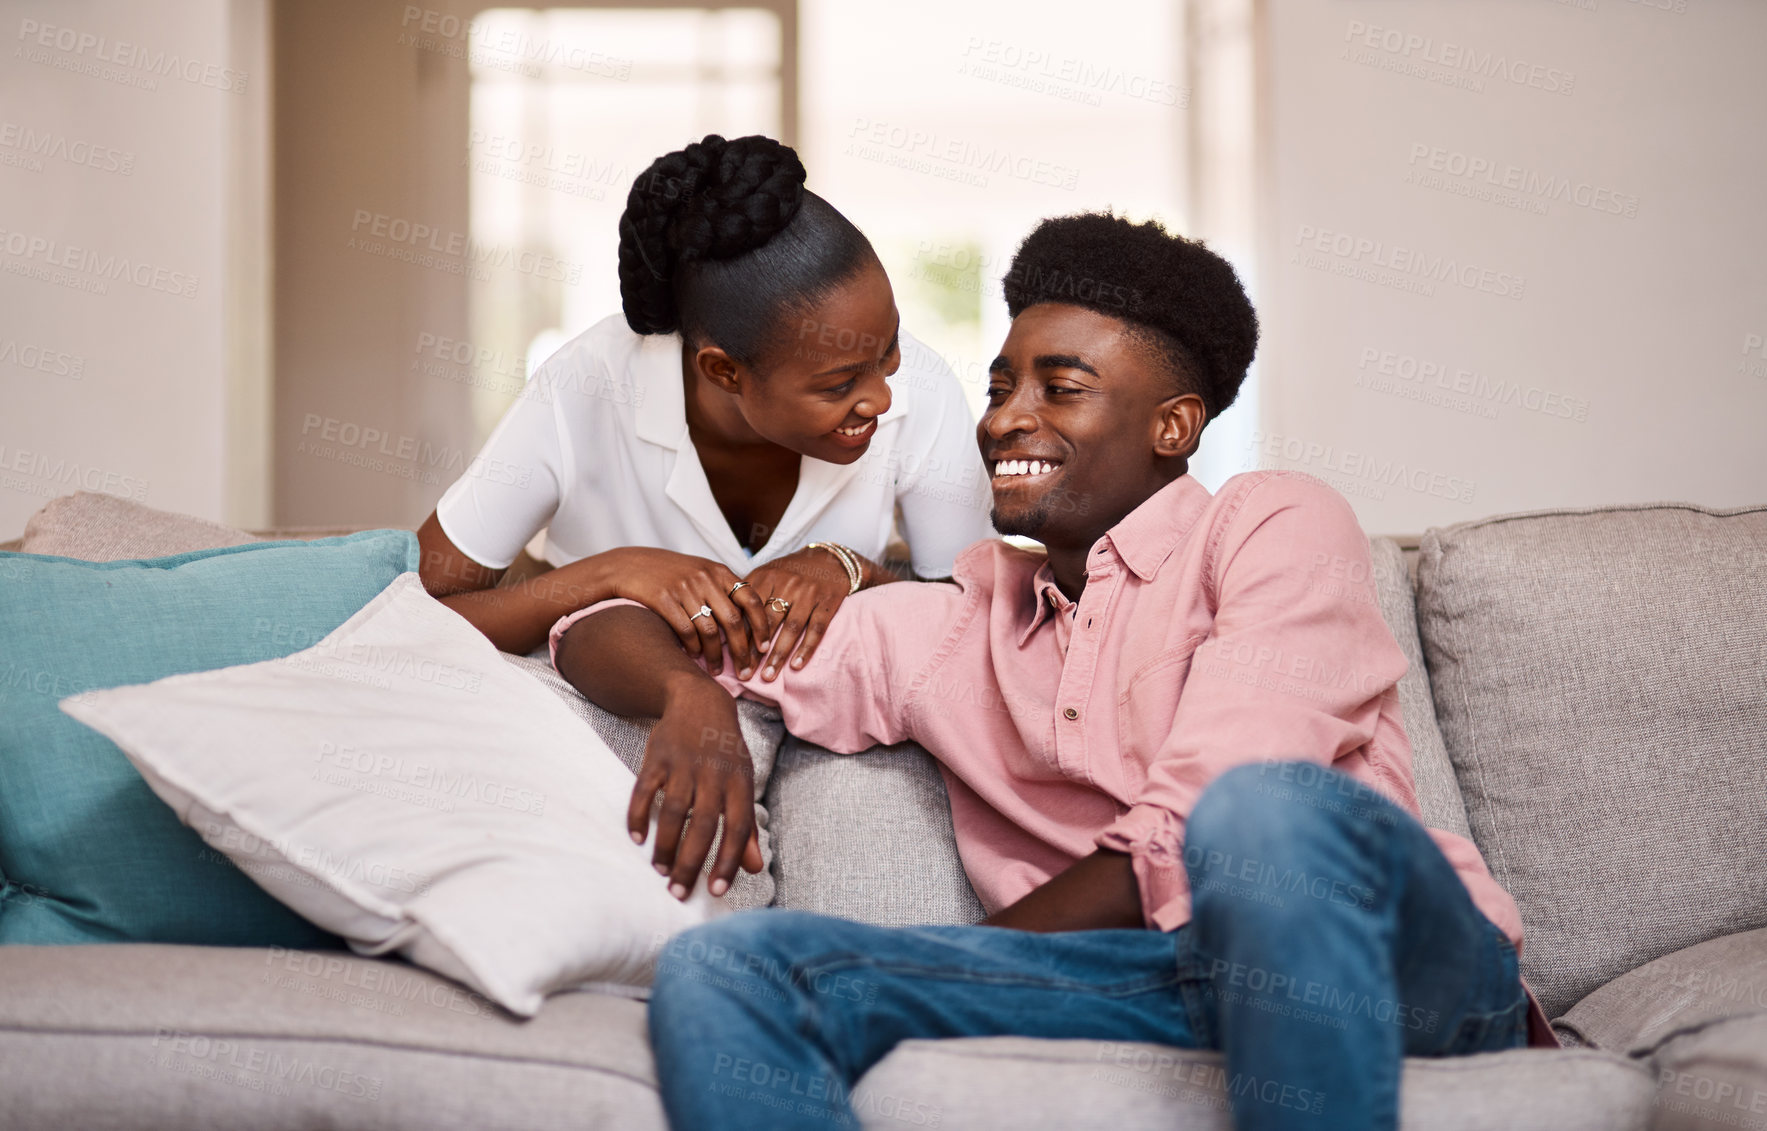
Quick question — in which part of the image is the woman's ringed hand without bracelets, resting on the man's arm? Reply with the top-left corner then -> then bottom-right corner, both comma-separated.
595,546 -> 770,677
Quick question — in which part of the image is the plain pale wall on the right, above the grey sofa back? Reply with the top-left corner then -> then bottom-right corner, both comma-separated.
1258,0 -> 1767,532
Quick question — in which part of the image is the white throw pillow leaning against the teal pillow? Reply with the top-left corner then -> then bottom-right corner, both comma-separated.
62,573 -> 724,1016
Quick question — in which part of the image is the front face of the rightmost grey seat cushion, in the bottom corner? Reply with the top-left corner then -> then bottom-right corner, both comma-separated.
1650,1013 -> 1767,1131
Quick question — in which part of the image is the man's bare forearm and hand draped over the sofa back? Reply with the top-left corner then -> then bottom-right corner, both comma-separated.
555,604 -> 762,899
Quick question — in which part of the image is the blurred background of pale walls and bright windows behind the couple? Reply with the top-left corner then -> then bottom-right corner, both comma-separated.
0,0 -> 1767,539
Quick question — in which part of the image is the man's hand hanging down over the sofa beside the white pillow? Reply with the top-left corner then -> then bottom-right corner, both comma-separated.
626,677 -> 762,899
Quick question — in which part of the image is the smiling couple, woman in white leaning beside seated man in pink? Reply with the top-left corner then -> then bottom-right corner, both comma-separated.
422,138 -> 1550,1127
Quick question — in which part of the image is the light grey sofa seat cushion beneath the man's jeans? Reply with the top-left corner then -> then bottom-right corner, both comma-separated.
853,1037 -> 1652,1131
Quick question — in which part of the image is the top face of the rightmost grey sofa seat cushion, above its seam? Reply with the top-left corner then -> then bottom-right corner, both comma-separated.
1553,930 -> 1767,1053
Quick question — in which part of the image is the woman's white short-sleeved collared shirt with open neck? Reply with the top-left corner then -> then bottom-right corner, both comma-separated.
436,315 -> 995,578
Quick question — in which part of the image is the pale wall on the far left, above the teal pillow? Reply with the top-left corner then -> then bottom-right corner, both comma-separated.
0,0 -> 269,537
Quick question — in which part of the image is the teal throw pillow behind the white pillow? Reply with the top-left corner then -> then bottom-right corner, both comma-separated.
0,530 -> 417,961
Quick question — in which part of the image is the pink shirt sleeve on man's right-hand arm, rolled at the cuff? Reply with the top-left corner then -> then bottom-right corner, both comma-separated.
1094,472 -> 1415,930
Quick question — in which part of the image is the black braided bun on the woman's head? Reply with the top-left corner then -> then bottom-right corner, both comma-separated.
620,134 -> 804,334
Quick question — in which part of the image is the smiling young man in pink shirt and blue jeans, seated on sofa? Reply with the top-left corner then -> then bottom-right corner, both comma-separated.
553,216 -> 1530,1129
